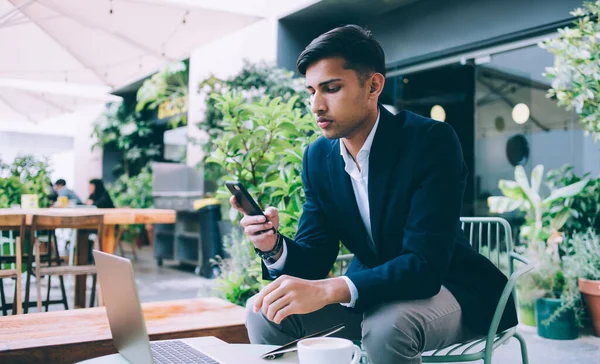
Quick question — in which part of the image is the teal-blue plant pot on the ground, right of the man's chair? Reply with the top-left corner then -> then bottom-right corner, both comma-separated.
535,298 -> 579,340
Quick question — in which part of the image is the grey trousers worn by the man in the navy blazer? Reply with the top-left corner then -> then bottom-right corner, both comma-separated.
246,287 -> 473,364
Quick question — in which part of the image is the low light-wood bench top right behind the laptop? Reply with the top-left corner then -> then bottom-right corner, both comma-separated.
0,298 -> 245,355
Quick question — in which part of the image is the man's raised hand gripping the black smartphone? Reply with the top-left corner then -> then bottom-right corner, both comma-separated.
229,196 -> 281,259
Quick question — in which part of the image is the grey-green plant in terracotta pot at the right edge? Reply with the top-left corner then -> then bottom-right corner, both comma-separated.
564,228 -> 600,336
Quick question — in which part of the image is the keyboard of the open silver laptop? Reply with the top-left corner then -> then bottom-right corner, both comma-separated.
150,340 -> 220,364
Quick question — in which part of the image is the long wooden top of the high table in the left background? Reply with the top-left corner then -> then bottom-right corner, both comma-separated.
0,207 -> 176,225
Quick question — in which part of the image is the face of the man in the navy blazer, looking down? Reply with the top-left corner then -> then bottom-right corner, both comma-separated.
306,57 -> 376,139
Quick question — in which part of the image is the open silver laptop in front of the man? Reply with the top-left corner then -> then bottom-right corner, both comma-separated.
93,250 -> 223,364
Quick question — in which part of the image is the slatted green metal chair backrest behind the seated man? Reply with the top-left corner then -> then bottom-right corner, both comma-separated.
460,217 -> 514,276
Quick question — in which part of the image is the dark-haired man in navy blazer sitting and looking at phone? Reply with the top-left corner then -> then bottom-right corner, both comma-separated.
230,25 -> 517,364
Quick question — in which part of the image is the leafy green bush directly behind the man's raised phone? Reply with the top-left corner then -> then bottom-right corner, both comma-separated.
207,92 -> 317,305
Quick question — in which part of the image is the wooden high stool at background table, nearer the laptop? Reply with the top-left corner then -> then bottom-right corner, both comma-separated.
25,213 -> 104,311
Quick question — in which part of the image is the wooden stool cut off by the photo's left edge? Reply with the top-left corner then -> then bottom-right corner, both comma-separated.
0,214 -> 26,315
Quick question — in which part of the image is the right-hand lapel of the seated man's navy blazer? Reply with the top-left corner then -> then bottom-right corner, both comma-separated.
369,105 -> 404,253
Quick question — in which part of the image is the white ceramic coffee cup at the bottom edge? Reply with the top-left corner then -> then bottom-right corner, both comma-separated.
298,337 -> 361,364
